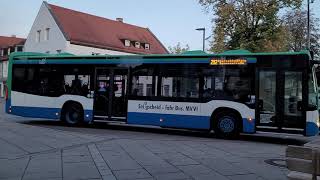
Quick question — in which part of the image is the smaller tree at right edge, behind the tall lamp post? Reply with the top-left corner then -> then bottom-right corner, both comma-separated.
283,9 -> 320,56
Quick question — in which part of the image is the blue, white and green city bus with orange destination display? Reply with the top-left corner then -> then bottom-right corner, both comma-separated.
6,50 -> 319,138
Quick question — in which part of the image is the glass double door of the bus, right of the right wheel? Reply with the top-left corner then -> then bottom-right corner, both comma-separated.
256,69 -> 305,133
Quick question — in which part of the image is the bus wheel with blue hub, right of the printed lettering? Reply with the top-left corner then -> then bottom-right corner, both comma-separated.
213,111 -> 240,139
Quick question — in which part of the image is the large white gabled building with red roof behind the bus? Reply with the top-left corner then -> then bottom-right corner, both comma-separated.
25,2 -> 168,55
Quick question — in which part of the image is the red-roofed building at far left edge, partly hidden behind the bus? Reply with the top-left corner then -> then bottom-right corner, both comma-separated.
0,36 -> 26,97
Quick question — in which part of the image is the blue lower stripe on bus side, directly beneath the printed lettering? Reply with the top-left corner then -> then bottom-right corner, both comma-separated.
128,112 -> 210,129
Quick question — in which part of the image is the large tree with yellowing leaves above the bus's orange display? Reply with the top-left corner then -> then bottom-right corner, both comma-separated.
199,0 -> 301,52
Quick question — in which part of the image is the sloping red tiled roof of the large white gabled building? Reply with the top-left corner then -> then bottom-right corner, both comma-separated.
48,4 -> 168,54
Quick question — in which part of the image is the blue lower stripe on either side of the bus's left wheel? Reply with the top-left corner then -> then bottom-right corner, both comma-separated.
7,106 -> 93,122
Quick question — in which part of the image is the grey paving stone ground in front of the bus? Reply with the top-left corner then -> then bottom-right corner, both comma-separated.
0,99 -> 287,180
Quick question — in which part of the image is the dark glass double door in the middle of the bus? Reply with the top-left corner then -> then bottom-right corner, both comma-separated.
94,68 -> 128,121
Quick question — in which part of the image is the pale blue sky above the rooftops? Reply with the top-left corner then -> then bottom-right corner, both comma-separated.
0,0 -> 320,50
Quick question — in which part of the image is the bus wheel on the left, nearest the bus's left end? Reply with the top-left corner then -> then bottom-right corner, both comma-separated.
62,102 -> 84,126
